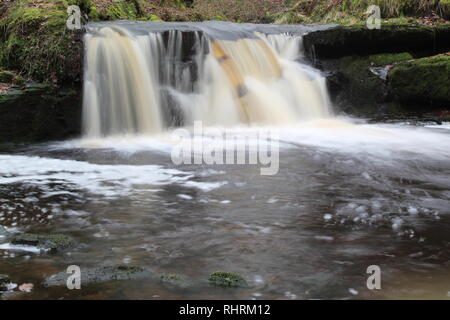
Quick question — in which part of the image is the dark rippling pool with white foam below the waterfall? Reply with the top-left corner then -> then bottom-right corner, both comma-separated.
0,120 -> 450,299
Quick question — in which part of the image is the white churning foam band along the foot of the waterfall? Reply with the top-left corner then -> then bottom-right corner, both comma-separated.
57,118 -> 450,165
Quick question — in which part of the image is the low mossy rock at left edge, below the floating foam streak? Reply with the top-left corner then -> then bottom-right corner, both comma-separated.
11,233 -> 75,252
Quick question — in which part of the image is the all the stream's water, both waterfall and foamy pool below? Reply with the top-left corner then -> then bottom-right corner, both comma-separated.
0,22 -> 450,299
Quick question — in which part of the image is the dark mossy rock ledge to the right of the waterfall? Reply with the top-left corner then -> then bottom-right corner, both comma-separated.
304,24 -> 450,117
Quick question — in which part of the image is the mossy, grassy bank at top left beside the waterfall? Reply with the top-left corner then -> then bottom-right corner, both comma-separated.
0,0 -> 81,83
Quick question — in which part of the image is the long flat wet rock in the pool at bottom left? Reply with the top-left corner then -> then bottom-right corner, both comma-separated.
44,265 -> 151,287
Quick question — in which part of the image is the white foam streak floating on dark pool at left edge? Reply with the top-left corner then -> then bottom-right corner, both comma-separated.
0,155 -> 226,197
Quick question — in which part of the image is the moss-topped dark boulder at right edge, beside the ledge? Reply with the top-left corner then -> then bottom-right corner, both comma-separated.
388,54 -> 450,107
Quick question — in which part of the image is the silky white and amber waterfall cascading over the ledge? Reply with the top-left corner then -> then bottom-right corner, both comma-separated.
83,23 -> 330,137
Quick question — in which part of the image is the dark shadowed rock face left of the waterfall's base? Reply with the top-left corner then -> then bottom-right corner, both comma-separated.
0,83 -> 81,143
